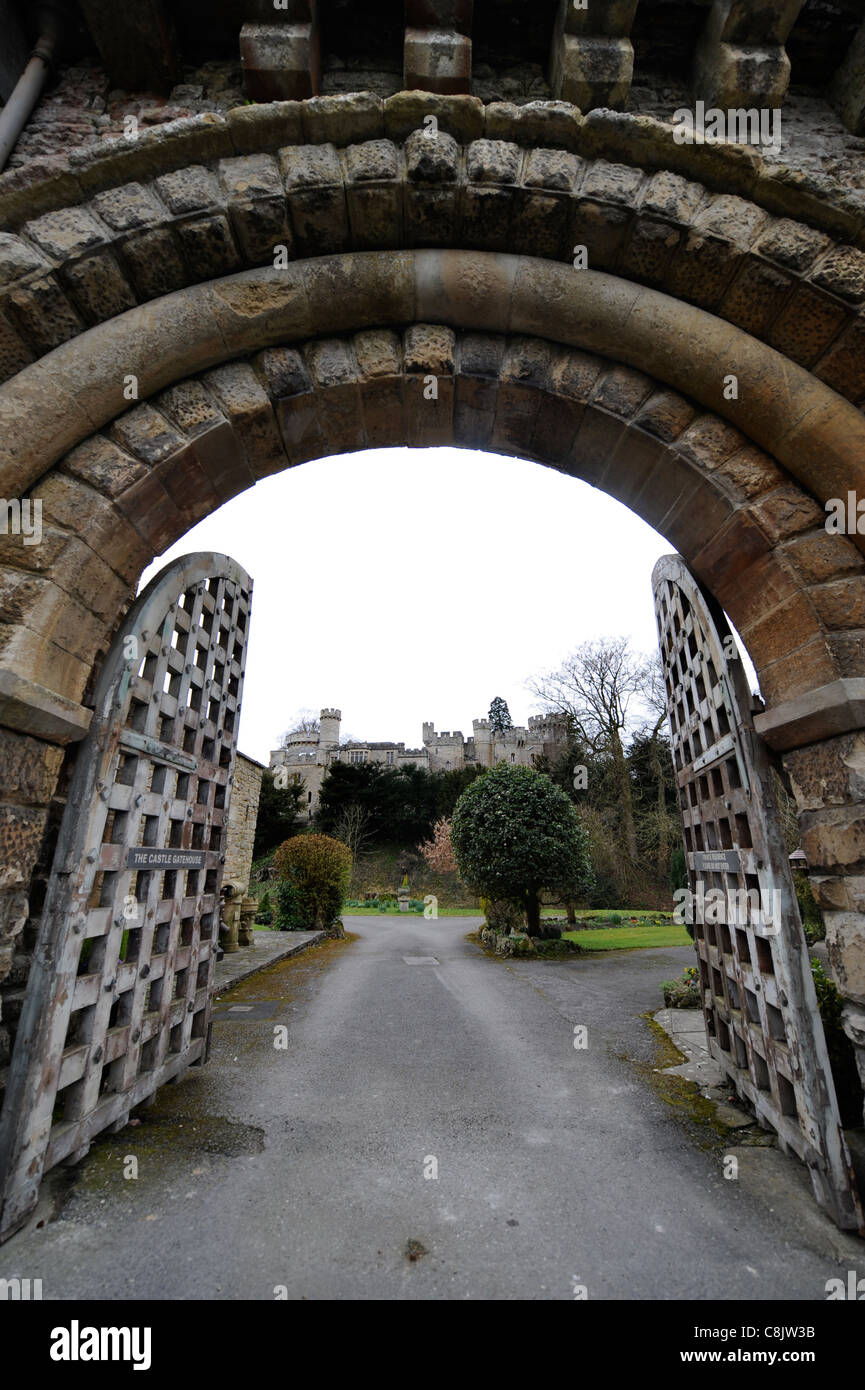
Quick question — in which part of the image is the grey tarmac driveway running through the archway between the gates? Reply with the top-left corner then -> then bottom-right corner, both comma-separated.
0,916 -> 862,1301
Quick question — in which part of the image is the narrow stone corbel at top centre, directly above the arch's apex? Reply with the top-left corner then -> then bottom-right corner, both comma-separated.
403,0 -> 474,96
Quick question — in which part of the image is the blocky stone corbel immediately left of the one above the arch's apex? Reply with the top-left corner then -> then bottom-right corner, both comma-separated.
241,0 -> 321,101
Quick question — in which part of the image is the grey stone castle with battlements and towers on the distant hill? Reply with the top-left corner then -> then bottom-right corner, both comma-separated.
270,709 -> 567,820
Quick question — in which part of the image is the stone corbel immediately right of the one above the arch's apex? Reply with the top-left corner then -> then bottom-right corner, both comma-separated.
549,0 -> 637,111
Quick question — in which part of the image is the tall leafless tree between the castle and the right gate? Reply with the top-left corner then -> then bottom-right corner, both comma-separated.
527,637 -> 661,865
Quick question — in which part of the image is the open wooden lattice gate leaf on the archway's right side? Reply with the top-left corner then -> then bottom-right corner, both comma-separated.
652,556 -> 862,1229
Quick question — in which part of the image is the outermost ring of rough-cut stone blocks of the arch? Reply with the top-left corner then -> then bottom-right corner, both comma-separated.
0,101 -> 865,402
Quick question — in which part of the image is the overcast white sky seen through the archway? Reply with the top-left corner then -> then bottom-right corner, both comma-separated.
142,449 -> 728,763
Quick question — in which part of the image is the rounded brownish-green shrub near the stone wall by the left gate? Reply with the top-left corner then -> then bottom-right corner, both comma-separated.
274,835 -> 352,931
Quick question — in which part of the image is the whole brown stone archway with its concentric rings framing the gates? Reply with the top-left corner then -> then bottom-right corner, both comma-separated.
0,93 -> 865,1239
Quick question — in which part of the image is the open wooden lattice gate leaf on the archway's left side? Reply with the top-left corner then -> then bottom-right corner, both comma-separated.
0,553 -> 252,1238
